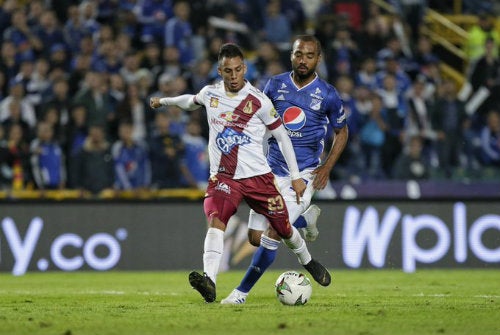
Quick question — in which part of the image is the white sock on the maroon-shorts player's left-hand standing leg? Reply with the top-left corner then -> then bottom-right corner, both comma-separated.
203,228 -> 224,283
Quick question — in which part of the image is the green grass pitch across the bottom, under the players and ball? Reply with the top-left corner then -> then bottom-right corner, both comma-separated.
0,269 -> 500,335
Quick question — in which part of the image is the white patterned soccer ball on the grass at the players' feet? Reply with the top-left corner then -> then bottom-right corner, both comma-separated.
275,271 -> 312,306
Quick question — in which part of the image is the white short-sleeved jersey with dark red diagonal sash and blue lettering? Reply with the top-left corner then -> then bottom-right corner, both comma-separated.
194,81 -> 281,179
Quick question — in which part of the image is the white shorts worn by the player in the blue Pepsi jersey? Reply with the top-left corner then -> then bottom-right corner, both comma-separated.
248,169 -> 314,231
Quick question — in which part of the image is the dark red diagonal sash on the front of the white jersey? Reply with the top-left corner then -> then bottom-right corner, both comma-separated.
218,94 -> 262,177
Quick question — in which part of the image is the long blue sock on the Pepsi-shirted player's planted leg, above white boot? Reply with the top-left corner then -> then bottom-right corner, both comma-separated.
237,235 -> 280,293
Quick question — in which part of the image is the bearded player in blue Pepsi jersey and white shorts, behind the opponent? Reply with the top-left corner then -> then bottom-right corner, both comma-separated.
221,35 -> 348,304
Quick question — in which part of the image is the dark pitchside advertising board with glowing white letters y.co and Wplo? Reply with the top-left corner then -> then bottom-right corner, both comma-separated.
0,201 -> 500,275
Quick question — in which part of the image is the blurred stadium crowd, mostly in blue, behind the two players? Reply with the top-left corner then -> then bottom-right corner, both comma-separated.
0,0 -> 500,198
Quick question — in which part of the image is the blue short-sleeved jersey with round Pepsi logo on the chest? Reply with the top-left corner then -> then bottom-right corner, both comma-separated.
264,72 -> 346,176
